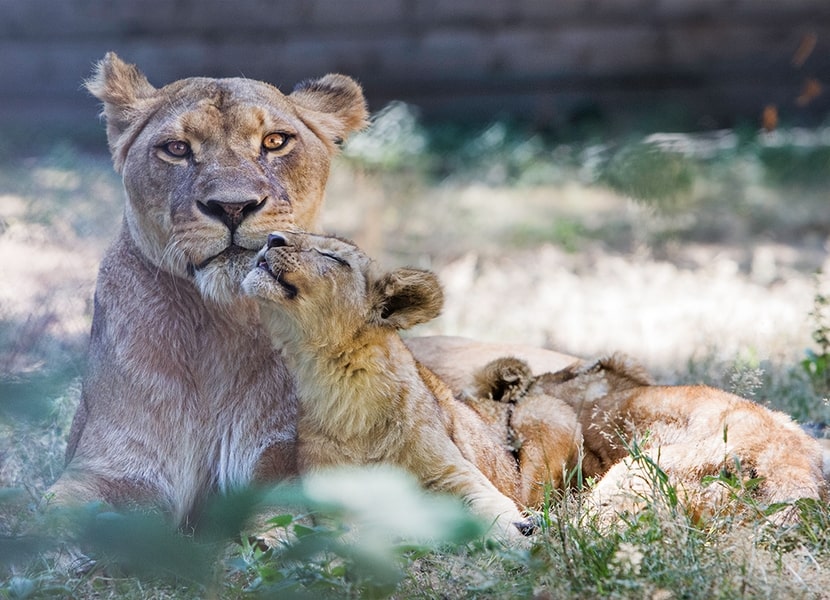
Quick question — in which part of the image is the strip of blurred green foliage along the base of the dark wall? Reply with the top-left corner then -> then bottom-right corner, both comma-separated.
343,102 -> 830,192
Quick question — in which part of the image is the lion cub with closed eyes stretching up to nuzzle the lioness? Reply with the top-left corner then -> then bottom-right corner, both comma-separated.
243,232 -> 527,537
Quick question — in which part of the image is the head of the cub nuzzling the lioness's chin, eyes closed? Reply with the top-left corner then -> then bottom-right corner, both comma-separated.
242,232 -> 443,348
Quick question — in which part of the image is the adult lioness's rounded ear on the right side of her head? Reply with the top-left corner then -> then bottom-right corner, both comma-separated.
288,73 -> 369,148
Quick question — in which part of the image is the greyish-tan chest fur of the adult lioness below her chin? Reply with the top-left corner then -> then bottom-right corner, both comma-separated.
67,234 -> 296,519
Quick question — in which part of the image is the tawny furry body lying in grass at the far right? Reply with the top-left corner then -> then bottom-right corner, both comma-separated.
528,355 -> 825,522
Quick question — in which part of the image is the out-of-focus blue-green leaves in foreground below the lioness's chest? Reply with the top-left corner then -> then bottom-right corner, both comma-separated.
0,467 -> 485,598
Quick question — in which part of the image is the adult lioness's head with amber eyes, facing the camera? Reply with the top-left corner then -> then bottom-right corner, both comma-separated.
86,53 -> 367,302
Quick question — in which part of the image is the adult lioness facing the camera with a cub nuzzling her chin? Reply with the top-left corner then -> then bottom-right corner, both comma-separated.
46,53 -> 574,523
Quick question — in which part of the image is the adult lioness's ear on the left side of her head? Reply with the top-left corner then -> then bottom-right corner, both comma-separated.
85,52 -> 156,169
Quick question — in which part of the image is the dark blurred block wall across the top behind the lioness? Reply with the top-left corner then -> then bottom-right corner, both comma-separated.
0,0 -> 830,137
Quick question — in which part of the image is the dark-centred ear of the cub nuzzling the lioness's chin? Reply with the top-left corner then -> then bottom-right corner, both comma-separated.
372,268 -> 444,329
